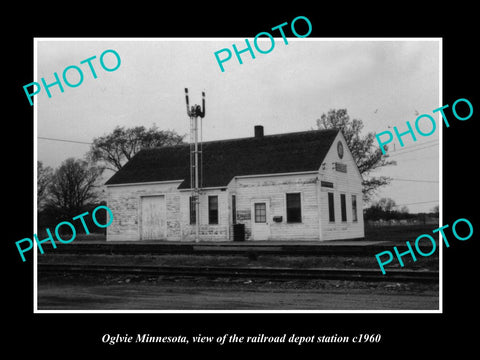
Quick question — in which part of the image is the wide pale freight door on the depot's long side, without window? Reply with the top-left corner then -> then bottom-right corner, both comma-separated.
141,195 -> 166,240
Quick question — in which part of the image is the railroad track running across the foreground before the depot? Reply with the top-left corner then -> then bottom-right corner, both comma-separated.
38,264 -> 439,283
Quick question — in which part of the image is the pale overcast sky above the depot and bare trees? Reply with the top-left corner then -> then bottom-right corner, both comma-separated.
35,37 -> 443,212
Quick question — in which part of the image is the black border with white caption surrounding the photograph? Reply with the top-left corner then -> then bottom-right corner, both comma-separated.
6,2 -> 480,357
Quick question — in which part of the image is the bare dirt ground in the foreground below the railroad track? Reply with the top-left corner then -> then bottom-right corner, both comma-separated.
38,275 -> 439,310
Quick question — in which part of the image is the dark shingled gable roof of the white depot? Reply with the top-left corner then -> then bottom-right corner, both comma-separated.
105,129 -> 339,189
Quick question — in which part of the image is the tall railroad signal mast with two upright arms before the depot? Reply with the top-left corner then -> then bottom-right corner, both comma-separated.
185,88 -> 205,242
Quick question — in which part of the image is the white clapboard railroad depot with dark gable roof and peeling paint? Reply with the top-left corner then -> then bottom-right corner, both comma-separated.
106,126 -> 364,241
